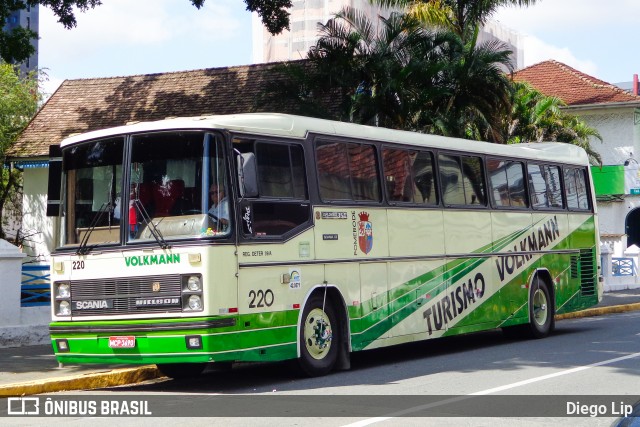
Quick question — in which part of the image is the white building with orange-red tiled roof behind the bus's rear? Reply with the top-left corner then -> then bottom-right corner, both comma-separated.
515,60 -> 640,288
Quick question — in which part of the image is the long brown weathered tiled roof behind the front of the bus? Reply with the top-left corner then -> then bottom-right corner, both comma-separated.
7,63 -> 298,158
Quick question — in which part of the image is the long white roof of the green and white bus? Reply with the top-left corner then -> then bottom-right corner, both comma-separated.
60,113 -> 589,165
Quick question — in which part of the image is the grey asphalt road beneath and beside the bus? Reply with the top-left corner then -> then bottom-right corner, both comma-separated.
6,311 -> 640,427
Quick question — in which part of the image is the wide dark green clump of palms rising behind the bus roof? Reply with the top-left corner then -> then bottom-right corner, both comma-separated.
258,9 -> 511,142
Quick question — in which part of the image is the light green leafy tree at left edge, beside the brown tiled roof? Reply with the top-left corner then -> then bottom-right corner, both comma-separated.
0,63 -> 40,238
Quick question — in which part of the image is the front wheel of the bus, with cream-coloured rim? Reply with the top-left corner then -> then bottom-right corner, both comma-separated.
298,293 -> 341,377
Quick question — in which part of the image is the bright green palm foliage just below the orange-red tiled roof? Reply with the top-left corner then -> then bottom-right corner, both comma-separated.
504,82 -> 602,165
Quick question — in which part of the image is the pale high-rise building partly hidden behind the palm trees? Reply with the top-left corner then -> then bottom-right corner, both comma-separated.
252,0 -> 523,69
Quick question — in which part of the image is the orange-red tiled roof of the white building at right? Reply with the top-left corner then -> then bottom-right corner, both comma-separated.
513,60 -> 640,106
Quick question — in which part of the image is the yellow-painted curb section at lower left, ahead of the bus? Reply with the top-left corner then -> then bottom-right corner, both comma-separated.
0,365 -> 163,397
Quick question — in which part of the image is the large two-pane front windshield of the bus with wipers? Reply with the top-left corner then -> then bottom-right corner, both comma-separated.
60,131 -> 232,248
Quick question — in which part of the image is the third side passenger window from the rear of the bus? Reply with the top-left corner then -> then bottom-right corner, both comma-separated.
487,159 -> 527,208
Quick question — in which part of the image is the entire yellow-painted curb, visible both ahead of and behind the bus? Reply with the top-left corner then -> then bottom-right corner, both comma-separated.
0,303 -> 640,398
